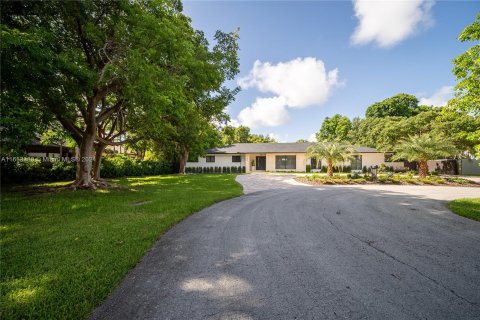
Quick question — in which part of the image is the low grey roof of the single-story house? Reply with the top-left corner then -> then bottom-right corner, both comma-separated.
206,142 -> 378,154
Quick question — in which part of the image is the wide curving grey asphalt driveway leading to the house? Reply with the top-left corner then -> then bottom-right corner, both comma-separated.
92,175 -> 480,319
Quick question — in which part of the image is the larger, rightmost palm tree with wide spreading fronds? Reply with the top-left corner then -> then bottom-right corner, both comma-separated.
393,133 -> 458,178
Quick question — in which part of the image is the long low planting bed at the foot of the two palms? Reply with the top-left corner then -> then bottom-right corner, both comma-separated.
295,173 -> 480,187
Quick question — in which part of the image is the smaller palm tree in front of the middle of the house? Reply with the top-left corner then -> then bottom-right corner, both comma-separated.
307,141 -> 354,177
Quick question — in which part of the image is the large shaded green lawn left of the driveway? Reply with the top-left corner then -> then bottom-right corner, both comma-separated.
0,175 -> 242,319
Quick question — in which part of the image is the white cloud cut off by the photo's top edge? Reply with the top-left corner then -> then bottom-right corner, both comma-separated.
351,0 -> 435,48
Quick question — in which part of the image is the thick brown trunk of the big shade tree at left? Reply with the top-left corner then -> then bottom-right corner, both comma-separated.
75,134 -> 95,189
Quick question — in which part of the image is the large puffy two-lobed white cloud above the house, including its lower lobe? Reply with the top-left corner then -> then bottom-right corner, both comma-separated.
238,57 -> 340,127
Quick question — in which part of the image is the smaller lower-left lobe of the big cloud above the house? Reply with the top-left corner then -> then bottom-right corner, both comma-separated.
238,97 -> 289,128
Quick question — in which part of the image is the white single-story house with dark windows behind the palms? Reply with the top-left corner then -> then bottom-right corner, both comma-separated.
186,142 -> 404,172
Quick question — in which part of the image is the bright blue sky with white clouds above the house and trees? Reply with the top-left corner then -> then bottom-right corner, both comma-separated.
184,0 -> 480,142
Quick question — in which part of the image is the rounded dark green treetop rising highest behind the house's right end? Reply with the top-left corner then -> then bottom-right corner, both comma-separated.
365,93 -> 421,118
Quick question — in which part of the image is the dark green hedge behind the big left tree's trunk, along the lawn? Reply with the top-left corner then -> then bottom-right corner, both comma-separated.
1,155 -> 173,183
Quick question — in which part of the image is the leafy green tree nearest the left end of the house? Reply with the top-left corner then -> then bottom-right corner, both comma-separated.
139,31 -> 239,173
